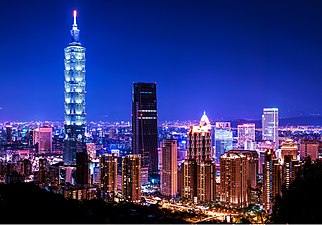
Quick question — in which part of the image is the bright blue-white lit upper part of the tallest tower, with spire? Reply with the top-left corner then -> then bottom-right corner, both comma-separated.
64,11 -> 86,128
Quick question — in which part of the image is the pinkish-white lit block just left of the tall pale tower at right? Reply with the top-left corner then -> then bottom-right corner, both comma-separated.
237,123 -> 255,150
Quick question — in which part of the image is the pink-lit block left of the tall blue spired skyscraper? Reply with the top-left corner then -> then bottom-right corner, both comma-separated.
33,127 -> 53,154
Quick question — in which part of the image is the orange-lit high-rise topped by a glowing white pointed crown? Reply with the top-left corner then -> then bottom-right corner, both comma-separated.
179,114 -> 216,202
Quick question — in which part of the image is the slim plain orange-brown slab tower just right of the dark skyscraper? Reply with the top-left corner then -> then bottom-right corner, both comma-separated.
160,140 -> 178,197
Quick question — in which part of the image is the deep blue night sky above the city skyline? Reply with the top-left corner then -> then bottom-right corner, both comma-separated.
0,0 -> 322,121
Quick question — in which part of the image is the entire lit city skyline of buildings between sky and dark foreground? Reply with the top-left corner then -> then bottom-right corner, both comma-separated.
0,12 -> 321,214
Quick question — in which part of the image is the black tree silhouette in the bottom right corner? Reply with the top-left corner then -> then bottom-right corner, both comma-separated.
271,157 -> 322,224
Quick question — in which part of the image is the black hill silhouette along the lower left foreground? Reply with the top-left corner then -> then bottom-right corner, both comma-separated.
0,183 -> 185,224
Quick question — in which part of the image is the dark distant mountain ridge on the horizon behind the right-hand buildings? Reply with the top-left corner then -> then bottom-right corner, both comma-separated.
231,116 -> 322,128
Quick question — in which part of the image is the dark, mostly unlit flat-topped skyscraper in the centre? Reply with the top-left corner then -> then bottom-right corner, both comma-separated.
132,82 -> 158,178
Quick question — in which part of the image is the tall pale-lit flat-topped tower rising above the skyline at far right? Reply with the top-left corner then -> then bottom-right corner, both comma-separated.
262,108 -> 279,150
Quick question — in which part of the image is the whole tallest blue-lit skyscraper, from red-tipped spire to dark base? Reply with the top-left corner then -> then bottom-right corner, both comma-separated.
63,11 -> 86,165
